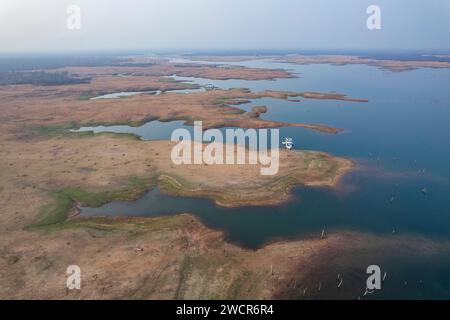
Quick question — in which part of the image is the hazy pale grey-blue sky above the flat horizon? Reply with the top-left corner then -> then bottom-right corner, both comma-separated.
0,0 -> 450,52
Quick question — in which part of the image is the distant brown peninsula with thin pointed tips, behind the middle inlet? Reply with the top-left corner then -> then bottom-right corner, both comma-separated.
0,84 -> 366,134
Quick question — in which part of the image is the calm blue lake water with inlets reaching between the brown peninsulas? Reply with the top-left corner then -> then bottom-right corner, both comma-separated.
78,60 -> 450,298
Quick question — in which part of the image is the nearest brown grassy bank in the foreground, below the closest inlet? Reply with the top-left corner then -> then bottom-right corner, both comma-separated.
0,208 -> 449,299
